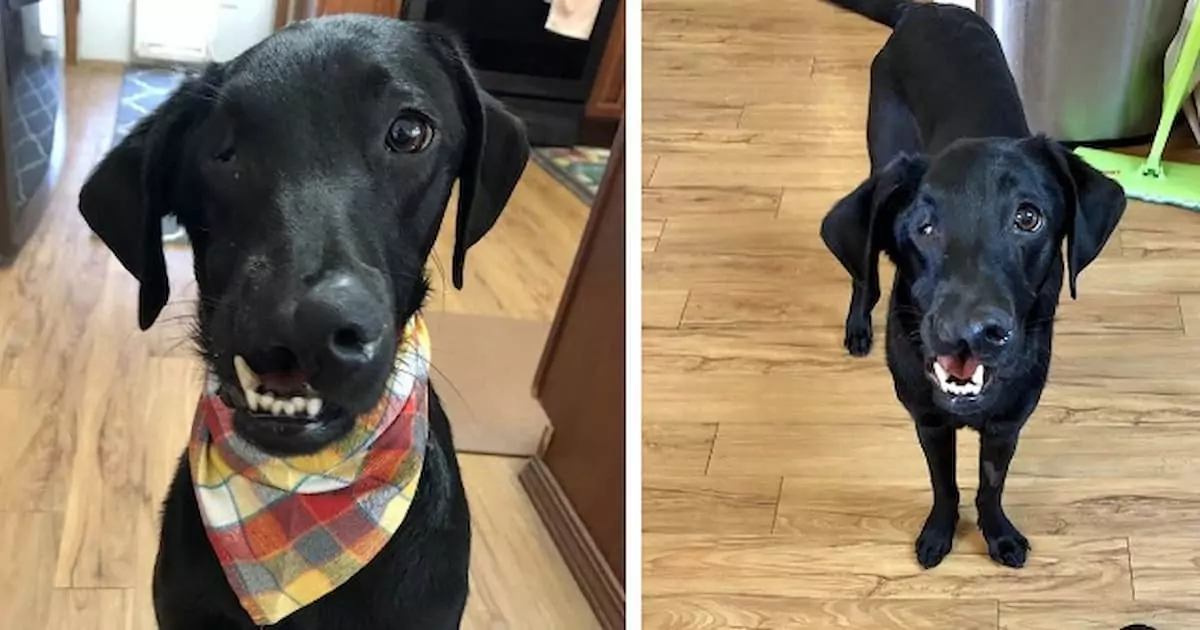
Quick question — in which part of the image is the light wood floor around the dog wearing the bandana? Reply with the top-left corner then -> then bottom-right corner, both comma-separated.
0,63 -> 596,630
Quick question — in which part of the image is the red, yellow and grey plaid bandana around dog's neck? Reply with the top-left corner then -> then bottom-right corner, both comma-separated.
188,316 -> 430,625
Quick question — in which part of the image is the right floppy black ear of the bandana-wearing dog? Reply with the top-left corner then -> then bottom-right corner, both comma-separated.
431,32 -> 529,289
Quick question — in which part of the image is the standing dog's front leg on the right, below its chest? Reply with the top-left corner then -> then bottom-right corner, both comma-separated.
976,428 -> 1030,569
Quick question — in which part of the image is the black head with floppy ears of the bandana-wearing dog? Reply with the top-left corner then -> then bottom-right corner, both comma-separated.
79,16 -> 529,455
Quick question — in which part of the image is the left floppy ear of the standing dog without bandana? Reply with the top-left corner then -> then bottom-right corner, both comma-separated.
821,155 -> 928,284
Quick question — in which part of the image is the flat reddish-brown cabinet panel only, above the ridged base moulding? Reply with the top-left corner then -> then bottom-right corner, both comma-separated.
534,119 -> 625,586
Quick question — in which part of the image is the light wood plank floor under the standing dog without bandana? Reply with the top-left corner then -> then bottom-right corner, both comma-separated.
642,0 -> 1200,630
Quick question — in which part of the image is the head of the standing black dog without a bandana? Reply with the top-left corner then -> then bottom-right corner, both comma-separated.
821,136 -> 1126,413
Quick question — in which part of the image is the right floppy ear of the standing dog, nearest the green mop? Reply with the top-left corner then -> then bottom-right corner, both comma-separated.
1039,136 -> 1126,300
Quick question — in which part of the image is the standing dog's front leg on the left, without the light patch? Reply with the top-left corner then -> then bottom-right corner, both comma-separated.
917,420 -> 959,569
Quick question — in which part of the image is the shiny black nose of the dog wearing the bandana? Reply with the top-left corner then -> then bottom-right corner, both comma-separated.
293,274 -> 384,372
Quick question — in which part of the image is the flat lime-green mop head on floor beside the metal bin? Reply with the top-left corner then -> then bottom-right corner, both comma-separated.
1075,146 -> 1200,211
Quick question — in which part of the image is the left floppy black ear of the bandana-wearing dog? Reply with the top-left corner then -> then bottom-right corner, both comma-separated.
79,73 -> 211,330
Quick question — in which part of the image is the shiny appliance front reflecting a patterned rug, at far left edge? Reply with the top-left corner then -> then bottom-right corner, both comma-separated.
0,0 -> 65,265
